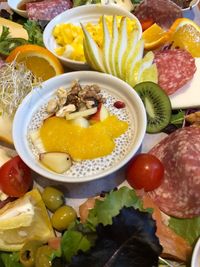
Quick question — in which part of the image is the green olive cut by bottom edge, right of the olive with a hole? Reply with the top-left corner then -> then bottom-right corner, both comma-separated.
35,245 -> 54,267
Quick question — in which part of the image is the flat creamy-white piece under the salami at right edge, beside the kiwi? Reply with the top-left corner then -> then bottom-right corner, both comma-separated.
170,58 -> 200,109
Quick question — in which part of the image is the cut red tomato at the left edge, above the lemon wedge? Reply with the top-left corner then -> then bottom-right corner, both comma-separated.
0,156 -> 33,197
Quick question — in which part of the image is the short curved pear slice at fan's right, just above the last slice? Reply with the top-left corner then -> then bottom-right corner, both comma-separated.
129,51 -> 154,86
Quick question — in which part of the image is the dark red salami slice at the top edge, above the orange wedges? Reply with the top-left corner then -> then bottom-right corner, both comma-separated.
134,0 -> 183,29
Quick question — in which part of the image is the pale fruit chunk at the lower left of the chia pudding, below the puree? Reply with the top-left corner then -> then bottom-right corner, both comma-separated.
39,152 -> 72,174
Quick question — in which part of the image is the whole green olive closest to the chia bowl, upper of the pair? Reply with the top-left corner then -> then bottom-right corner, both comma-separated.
42,186 -> 65,212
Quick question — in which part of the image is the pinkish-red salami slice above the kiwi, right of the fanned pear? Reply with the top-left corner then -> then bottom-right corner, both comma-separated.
154,49 -> 196,95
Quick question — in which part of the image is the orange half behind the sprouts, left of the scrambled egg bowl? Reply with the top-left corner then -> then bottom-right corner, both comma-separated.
6,44 -> 64,81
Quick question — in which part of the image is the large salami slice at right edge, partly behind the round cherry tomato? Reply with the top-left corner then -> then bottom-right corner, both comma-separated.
148,126 -> 200,218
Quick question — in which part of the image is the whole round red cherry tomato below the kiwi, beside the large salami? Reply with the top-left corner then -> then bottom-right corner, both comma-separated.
126,153 -> 164,192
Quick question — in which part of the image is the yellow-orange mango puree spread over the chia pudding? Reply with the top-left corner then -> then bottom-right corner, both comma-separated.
40,115 -> 128,160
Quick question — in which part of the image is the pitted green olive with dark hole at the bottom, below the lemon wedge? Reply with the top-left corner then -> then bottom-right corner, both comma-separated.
19,240 -> 43,267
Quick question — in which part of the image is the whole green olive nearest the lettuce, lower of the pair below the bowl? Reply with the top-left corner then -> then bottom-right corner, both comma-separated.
51,205 -> 76,231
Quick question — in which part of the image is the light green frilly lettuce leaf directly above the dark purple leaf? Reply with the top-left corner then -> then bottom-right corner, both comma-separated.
87,186 -> 144,228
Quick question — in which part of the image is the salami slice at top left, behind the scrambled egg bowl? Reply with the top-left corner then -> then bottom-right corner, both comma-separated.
26,0 -> 72,20
